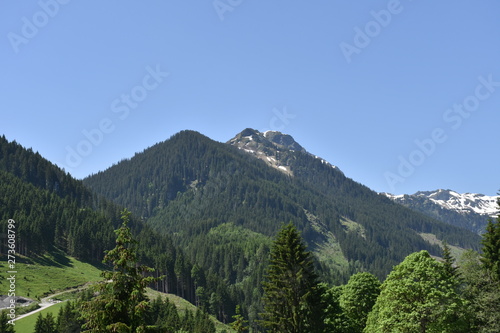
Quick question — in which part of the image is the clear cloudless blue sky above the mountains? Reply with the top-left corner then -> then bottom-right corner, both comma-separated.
0,0 -> 500,195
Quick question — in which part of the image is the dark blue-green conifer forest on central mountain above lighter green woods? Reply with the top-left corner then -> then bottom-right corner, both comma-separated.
84,131 -> 479,279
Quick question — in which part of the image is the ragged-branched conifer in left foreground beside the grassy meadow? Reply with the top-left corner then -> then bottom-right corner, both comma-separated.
82,210 -> 155,333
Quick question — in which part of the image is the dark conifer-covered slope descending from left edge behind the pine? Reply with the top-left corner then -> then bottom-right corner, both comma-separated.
0,136 -> 236,319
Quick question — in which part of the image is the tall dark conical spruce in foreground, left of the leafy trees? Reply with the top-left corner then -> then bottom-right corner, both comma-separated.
262,223 -> 324,333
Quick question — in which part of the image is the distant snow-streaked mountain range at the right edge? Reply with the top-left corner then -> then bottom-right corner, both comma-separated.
383,189 -> 499,234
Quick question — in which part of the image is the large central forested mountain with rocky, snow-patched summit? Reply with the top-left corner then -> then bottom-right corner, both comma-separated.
84,129 -> 480,321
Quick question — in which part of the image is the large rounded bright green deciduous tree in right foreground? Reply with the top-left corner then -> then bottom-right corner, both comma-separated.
364,251 -> 470,333
